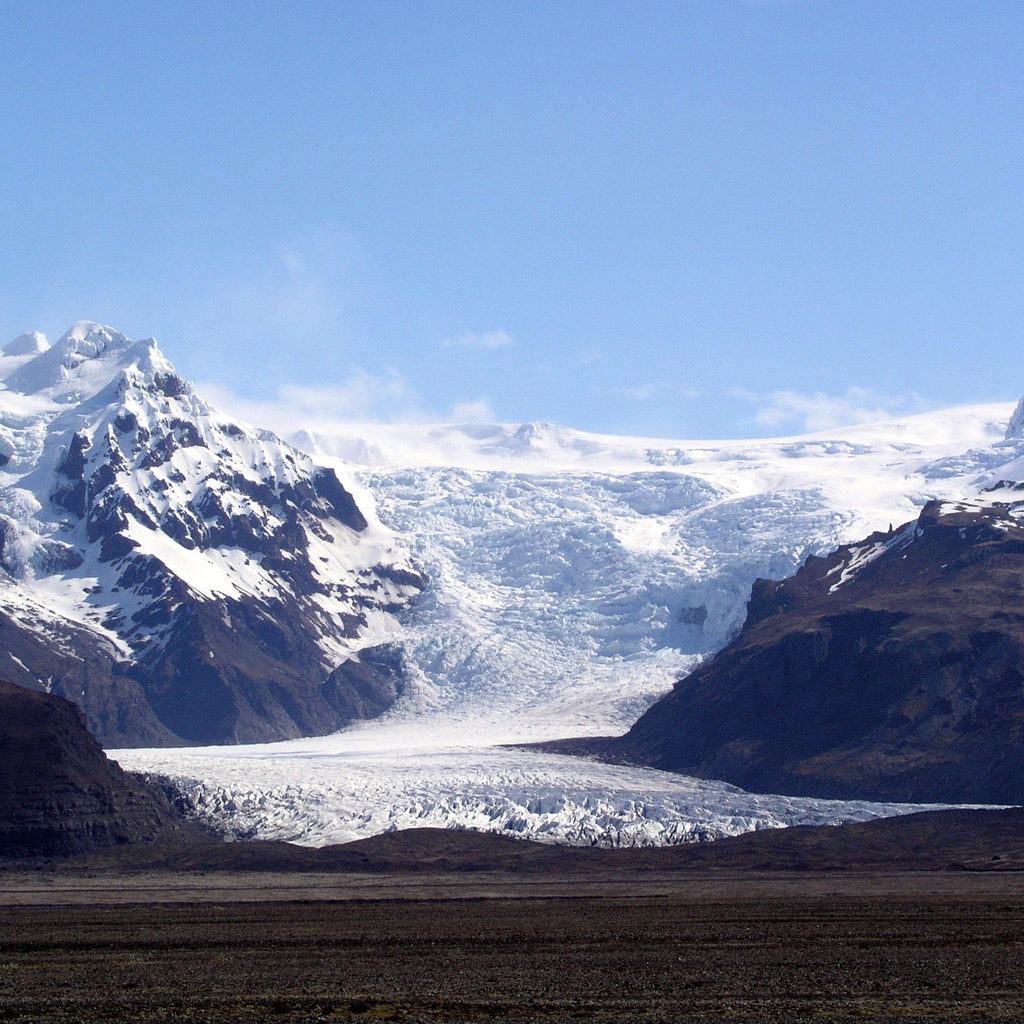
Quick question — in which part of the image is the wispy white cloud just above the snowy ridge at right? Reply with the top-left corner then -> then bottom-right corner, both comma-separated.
731,387 -> 928,433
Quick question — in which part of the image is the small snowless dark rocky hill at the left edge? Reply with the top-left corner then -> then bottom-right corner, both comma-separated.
0,682 -> 212,859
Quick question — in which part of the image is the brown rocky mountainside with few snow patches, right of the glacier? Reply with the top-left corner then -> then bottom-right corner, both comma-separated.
605,502 -> 1024,804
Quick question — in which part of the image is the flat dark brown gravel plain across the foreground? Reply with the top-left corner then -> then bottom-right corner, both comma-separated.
0,872 -> 1024,1024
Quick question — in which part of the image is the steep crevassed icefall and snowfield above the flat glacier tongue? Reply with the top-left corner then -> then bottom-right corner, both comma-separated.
296,406 -> 1024,741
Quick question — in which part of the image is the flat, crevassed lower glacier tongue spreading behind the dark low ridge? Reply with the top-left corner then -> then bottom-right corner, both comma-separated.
113,730 -> 942,847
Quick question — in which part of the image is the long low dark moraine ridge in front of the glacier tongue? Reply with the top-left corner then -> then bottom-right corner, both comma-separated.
75,808 -> 1024,882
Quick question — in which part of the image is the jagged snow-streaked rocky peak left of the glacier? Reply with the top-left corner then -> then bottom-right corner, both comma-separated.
0,323 -> 422,743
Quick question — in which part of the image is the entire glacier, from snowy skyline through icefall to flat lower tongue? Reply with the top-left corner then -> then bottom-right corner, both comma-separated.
117,395 -> 1024,845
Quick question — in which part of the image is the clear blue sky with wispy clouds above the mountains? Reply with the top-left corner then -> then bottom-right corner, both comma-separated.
0,0 -> 1024,437
